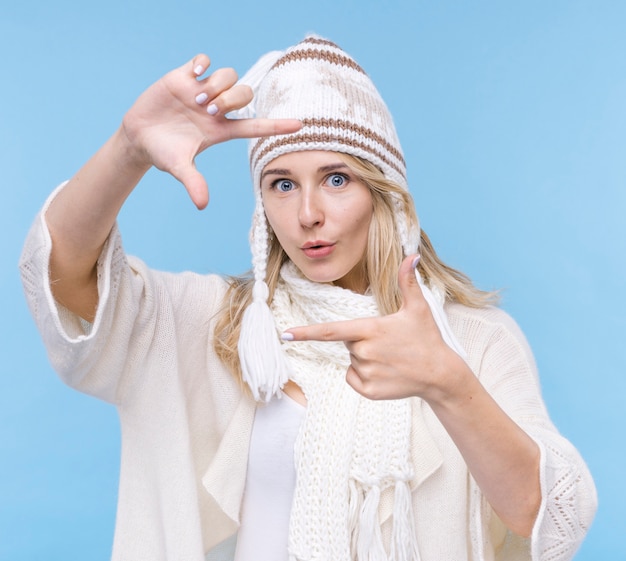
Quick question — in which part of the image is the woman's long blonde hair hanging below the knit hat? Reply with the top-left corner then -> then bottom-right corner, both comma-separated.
213,153 -> 498,380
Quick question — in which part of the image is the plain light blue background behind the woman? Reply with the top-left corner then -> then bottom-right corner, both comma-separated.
0,0 -> 626,561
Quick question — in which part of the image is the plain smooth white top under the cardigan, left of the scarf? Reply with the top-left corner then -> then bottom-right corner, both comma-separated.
235,395 -> 306,561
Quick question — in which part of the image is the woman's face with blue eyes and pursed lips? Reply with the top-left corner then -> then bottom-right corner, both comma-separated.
261,151 -> 373,293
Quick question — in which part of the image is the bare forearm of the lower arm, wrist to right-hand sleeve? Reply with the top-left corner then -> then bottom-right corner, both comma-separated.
429,356 -> 541,536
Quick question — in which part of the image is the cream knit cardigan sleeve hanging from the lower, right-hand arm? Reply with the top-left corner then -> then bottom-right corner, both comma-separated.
466,309 -> 597,561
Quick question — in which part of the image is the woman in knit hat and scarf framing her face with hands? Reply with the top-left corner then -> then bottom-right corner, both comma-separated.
21,36 -> 596,561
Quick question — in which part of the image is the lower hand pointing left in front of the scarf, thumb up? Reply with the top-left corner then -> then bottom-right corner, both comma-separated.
287,256 -> 469,401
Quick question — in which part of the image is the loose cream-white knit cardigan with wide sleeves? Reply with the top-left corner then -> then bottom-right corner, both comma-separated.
20,189 -> 597,561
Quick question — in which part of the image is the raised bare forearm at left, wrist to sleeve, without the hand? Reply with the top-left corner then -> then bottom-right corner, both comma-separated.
45,130 -> 149,320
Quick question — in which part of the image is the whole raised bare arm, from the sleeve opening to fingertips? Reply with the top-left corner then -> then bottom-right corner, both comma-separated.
46,55 -> 301,321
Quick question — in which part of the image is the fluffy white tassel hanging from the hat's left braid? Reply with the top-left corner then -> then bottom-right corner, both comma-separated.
237,280 -> 289,402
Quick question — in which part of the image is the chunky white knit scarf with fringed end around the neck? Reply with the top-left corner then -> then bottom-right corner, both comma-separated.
272,262 -> 419,561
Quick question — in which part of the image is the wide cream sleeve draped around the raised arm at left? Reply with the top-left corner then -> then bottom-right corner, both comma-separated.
19,184 -> 142,403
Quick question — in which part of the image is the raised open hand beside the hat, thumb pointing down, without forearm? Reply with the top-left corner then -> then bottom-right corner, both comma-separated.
121,54 -> 302,209
